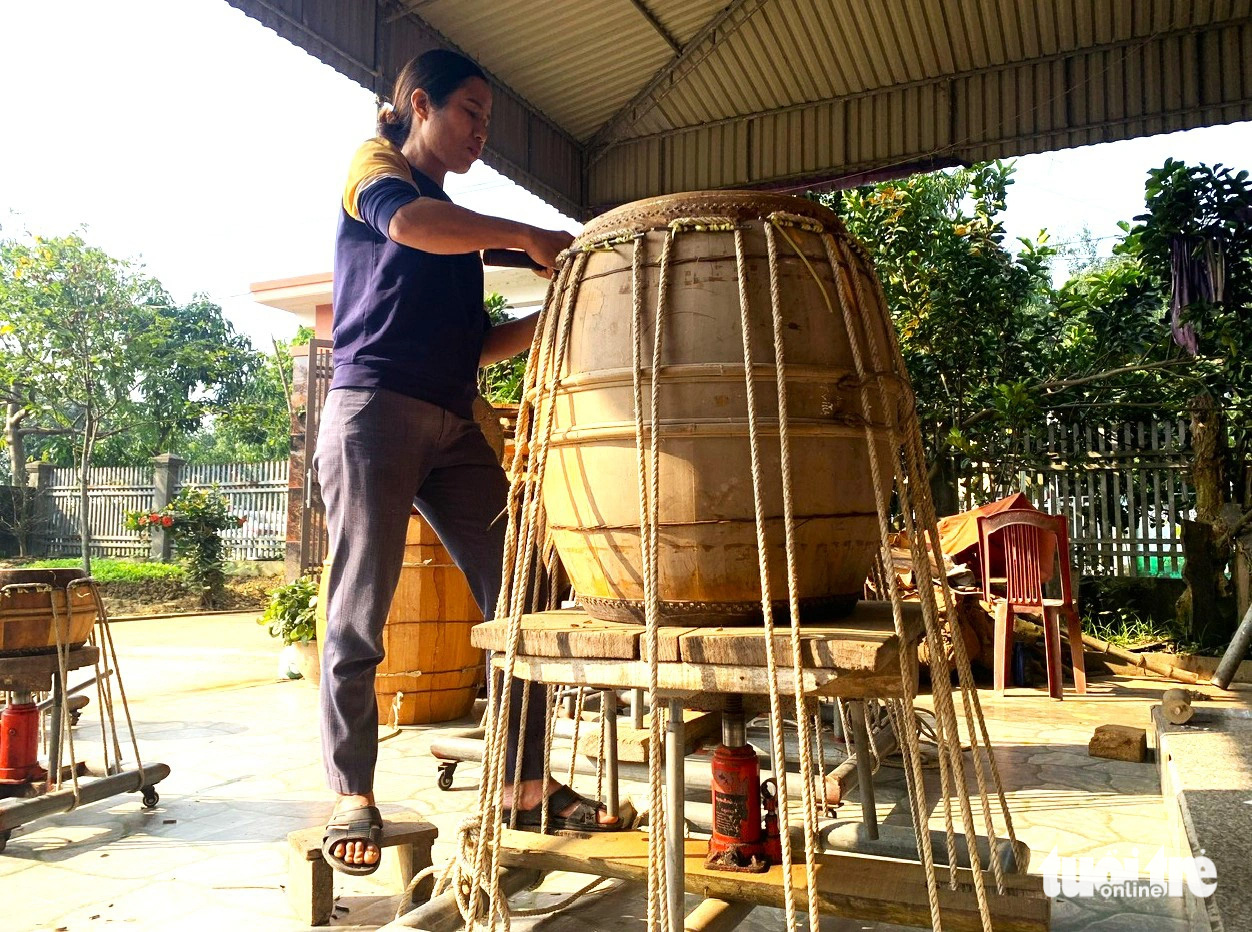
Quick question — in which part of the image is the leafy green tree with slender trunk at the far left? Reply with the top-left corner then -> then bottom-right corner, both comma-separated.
0,234 -> 254,571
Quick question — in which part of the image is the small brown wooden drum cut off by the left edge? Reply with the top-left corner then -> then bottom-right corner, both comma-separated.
0,569 -> 98,656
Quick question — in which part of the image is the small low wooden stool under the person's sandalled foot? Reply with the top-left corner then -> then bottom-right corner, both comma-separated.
287,814 -> 439,926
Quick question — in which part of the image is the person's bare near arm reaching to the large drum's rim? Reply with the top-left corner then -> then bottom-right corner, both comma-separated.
387,198 -> 573,268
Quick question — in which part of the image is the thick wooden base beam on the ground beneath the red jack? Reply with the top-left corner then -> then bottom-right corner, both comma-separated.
501,829 -> 1052,932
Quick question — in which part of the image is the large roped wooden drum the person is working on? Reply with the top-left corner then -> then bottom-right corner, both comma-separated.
542,192 -> 903,625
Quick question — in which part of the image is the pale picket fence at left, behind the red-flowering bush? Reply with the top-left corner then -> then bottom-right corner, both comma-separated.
36,460 -> 287,560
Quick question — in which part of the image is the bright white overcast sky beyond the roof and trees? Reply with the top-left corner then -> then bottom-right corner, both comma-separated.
0,0 -> 1252,347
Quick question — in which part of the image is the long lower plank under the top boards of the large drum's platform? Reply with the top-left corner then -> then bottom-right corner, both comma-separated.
496,650 -> 916,708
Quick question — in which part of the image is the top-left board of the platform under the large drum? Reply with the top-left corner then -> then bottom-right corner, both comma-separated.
470,609 -> 645,660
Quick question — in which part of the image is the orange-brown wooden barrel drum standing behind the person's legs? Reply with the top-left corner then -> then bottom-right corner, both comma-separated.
317,515 -> 485,725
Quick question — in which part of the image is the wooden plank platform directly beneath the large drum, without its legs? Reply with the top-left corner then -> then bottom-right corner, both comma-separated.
471,601 -> 923,699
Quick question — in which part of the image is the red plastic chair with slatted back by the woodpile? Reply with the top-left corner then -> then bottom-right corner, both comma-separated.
978,510 -> 1087,699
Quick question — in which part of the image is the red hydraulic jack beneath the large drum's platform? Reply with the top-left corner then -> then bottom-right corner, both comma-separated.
705,695 -> 781,873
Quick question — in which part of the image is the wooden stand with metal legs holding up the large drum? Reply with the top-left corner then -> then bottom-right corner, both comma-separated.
472,603 -> 1050,931
